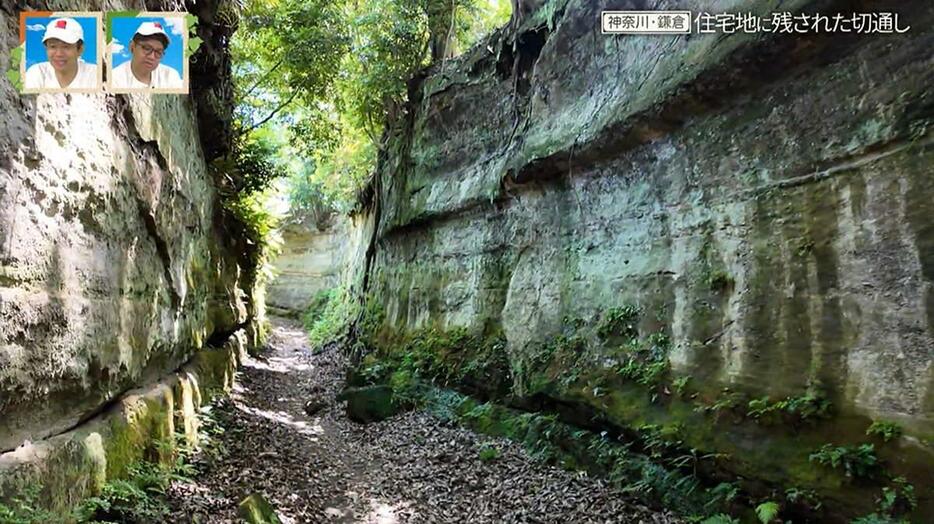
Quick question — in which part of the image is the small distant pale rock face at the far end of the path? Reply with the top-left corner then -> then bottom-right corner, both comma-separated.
266,217 -> 351,315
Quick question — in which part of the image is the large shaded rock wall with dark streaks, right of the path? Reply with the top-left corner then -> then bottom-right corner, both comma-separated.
354,0 -> 934,516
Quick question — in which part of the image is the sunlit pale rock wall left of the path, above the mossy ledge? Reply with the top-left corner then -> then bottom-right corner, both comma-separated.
0,2 -> 253,451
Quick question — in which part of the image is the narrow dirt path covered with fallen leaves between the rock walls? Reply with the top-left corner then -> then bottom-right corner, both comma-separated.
170,319 -> 676,524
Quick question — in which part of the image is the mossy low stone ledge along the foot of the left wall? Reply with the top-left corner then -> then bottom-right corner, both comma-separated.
0,327 -> 250,522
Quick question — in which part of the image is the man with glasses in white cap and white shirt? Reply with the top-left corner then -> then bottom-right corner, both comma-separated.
112,22 -> 185,89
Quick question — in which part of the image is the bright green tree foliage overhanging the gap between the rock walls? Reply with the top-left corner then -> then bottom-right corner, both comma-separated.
231,0 -> 510,220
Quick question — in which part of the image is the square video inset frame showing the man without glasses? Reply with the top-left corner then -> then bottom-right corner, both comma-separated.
22,13 -> 103,93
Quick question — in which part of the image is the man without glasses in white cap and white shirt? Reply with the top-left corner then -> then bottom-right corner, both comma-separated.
23,18 -> 99,89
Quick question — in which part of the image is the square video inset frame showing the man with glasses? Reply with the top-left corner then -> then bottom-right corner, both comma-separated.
107,13 -> 188,93
